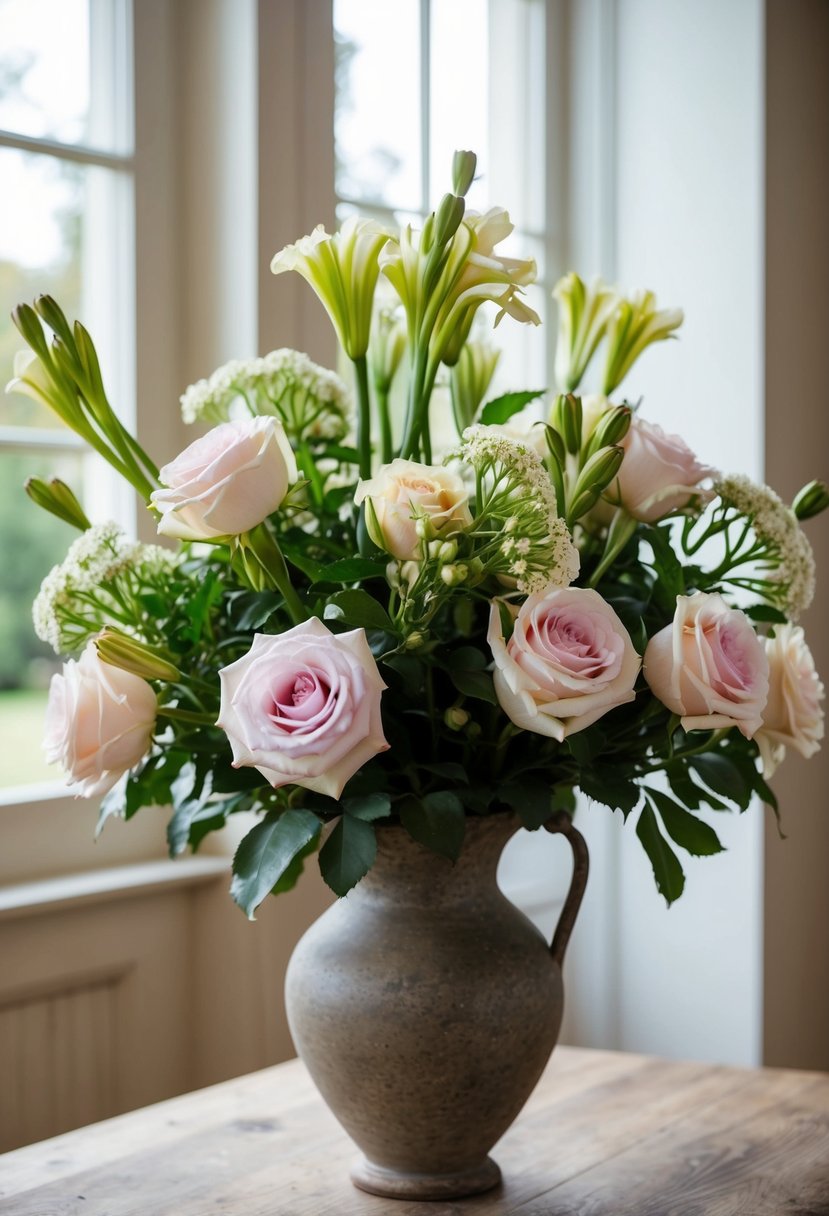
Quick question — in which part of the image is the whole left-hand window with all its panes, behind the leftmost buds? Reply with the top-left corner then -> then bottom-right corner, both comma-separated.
0,0 -> 135,792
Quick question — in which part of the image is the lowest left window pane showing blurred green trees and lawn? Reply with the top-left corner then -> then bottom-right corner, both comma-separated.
0,451 -> 84,788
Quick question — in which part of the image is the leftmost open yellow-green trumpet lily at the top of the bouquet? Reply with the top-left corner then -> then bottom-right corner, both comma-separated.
271,215 -> 390,359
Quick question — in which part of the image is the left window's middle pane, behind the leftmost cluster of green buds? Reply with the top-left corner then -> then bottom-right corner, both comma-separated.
0,147 -> 129,428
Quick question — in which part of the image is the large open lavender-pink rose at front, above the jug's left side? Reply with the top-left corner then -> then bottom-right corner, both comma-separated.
216,618 -> 388,798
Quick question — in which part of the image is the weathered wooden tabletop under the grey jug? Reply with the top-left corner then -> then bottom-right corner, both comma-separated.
0,1047 -> 829,1216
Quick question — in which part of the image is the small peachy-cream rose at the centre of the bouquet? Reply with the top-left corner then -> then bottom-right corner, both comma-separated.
354,460 -> 472,562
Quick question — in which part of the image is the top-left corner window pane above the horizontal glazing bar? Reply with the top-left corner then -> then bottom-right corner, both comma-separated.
0,0 -> 129,151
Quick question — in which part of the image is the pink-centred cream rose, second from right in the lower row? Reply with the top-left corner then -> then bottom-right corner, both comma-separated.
644,591 -> 768,739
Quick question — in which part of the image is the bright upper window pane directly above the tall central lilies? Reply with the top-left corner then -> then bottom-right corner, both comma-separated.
334,0 -> 423,210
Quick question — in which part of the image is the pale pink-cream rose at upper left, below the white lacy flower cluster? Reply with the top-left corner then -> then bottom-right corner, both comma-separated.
152,417 -> 297,540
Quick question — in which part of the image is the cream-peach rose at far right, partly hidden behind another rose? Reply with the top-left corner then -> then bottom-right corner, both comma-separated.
755,625 -> 824,777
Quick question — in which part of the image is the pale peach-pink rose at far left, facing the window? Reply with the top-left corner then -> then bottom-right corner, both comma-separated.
44,642 -> 157,798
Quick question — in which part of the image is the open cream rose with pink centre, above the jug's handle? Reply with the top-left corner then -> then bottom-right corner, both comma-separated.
487,587 -> 642,742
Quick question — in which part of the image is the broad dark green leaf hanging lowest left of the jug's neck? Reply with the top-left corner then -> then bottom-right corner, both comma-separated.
230,810 -> 322,921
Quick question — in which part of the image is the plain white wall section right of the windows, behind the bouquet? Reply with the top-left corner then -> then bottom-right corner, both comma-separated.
566,0 -> 763,1064
